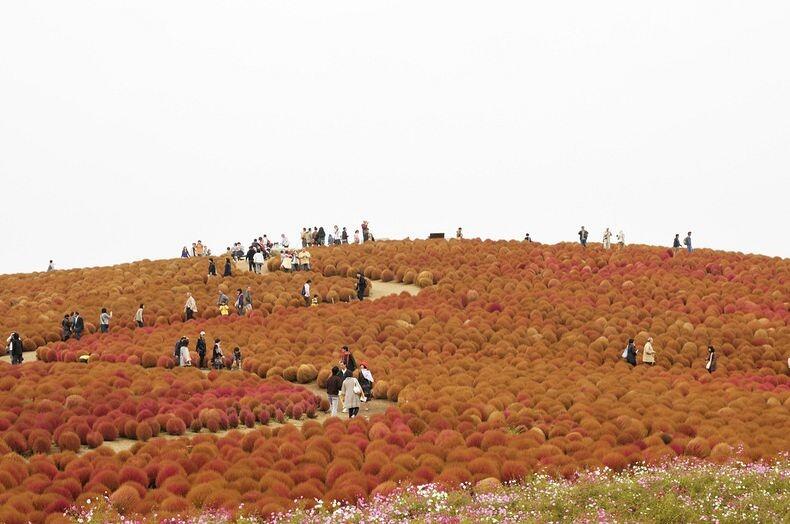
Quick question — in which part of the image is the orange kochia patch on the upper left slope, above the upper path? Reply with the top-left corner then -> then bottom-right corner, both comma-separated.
0,257 -> 362,350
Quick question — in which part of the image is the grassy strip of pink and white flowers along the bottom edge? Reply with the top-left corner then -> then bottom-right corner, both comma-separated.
69,456 -> 790,524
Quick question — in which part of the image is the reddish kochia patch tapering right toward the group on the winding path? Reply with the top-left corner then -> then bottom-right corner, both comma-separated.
0,362 -> 321,453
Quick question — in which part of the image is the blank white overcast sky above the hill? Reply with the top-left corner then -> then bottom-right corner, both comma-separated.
0,0 -> 790,273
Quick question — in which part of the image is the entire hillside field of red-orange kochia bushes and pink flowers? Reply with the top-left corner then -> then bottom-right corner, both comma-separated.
0,240 -> 790,522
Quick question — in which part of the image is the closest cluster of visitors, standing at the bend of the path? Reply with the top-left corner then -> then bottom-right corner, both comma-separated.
326,346 -> 373,418
